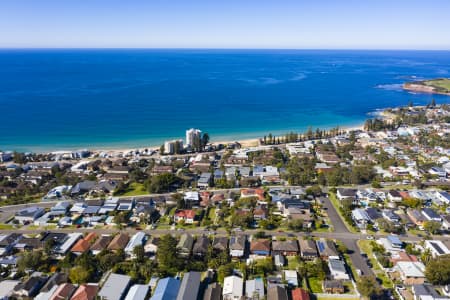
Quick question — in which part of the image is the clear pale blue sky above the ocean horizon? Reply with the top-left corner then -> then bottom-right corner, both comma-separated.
0,0 -> 450,50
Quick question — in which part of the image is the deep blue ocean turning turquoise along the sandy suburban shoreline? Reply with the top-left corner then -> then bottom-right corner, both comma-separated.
0,50 -> 450,151
